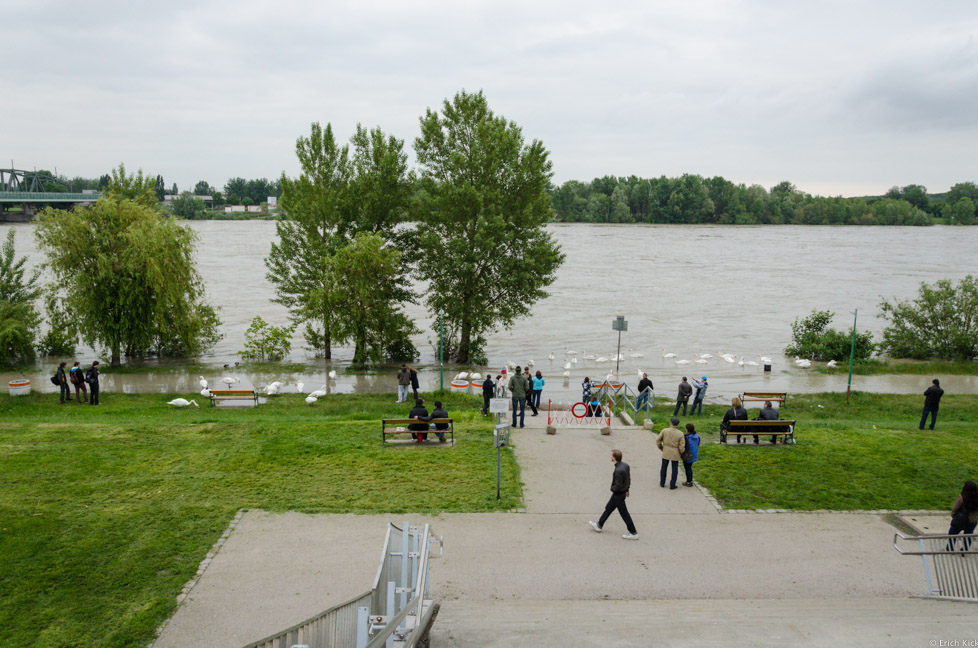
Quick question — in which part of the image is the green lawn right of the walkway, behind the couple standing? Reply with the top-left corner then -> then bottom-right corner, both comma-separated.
683,392 -> 978,510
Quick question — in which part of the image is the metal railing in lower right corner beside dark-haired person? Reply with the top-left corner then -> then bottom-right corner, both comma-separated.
893,533 -> 978,602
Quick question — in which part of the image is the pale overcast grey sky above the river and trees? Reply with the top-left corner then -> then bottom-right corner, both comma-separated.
0,0 -> 978,196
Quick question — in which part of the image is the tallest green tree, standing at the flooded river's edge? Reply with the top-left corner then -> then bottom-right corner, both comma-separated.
414,91 -> 564,363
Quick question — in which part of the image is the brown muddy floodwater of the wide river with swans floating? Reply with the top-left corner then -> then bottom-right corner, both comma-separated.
0,221 -> 978,402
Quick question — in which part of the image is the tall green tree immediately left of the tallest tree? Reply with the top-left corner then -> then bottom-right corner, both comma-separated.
265,123 -> 411,362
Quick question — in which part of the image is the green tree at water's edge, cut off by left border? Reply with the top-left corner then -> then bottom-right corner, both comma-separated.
0,229 -> 41,365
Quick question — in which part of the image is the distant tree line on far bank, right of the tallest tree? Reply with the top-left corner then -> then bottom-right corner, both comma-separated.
550,174 -> 978,225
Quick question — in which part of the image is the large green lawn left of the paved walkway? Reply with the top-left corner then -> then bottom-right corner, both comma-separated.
0,394 -> 522,647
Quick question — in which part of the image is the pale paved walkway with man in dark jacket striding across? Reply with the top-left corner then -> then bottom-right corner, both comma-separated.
156,427 -> 960,648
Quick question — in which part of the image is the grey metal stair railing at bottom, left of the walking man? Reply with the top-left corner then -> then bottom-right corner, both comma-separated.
245,522 -> 442,648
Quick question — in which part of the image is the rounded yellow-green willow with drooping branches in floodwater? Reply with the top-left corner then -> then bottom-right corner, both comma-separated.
35,166 -> 219,365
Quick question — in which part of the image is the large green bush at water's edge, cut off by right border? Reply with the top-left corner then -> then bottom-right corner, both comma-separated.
880,275 -> 978,361
